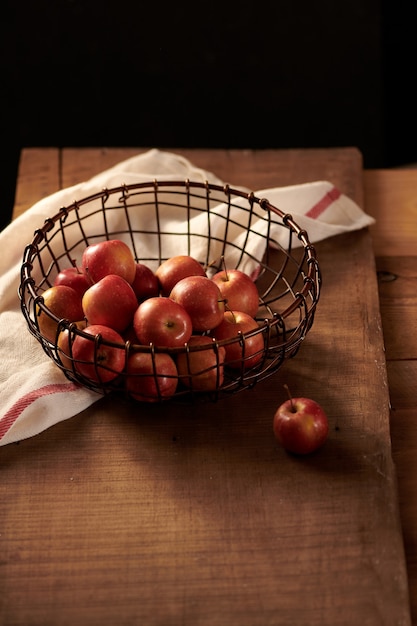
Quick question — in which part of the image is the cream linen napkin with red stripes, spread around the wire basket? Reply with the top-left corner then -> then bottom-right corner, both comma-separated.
0,149 -> 374,445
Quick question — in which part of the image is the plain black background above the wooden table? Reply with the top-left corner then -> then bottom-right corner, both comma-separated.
0,0 -> 417,227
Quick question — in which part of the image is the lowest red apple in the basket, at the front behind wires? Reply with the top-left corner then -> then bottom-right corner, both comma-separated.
126,352 -> 178,402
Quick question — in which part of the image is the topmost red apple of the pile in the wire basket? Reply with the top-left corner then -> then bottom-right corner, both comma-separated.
81,239 -> 136,283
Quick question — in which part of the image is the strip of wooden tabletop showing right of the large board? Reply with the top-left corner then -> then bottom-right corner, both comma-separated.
363,169 -> 417,624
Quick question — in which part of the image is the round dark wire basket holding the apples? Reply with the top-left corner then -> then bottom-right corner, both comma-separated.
19,180 -> 321,402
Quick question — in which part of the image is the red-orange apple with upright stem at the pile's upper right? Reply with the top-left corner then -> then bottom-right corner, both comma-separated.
212,269 -> 259,317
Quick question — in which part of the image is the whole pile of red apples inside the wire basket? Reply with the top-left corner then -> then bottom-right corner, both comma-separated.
35,239 -> 264,402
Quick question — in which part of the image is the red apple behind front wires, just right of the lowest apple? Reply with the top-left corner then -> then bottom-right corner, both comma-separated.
177,335 -> 225,391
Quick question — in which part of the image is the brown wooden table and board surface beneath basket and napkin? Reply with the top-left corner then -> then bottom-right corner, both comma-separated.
0,148 -> 417,626
